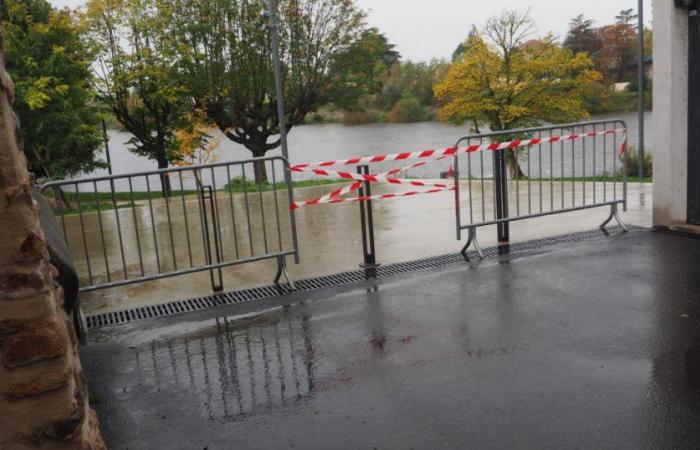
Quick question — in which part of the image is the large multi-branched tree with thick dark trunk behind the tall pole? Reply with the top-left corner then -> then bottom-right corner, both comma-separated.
171,0 -> 365,181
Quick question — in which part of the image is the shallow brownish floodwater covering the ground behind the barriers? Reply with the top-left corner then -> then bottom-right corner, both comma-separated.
79,182 -> 652,314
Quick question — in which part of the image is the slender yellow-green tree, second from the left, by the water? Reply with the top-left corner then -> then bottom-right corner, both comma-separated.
85,0 -> 191,196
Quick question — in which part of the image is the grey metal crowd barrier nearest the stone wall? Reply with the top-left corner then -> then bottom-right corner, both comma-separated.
41,156 -> 299,292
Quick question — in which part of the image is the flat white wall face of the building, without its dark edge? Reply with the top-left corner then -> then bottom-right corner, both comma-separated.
652,0 -> 688,227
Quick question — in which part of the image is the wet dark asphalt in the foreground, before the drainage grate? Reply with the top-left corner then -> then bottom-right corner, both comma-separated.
82,231 -> 700,450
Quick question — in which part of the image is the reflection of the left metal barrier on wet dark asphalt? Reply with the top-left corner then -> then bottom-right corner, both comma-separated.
129,315 -> 314,421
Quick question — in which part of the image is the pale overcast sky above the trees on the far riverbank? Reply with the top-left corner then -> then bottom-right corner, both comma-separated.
50,0 -> 652,61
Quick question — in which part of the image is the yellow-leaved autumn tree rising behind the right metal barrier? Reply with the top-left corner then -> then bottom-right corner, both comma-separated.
435,12 -> 600,177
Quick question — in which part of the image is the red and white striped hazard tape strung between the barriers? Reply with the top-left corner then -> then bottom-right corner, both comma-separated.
289,128 -> 627,209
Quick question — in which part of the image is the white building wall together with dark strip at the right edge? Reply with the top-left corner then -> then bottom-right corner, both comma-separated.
653,0 -> 700,230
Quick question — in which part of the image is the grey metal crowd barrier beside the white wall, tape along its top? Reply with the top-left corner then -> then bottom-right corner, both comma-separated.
453,120 -> 628,257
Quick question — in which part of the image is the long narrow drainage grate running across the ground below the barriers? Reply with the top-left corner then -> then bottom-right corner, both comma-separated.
86,227 -> 641,329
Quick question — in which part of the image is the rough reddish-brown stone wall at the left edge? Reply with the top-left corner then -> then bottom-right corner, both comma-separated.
0,29 -> 105,450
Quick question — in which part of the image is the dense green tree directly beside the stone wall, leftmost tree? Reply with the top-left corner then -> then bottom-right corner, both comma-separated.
0,0 -> 104,178
